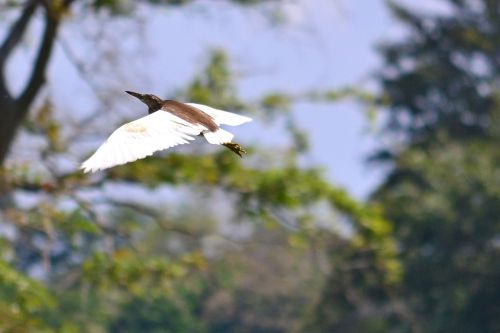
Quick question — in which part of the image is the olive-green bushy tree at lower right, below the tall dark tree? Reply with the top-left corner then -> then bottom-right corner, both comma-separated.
377,141 -> 500,332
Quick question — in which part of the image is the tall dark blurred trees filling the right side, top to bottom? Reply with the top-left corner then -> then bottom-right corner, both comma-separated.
312,0 -> 500,332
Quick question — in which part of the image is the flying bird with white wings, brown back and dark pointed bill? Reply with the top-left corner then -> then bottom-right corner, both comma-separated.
80,91 -> 252,173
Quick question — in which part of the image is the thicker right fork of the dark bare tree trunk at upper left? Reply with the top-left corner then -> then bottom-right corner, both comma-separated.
16,5 -> 59,115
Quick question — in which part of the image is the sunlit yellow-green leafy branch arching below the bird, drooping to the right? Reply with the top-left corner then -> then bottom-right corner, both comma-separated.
109,151 -> 400,281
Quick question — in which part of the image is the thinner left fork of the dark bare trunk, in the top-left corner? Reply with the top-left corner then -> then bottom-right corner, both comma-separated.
0,0 -> 37,97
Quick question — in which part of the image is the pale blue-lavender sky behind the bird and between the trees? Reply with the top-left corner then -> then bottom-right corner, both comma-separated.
8,0 -> 410,199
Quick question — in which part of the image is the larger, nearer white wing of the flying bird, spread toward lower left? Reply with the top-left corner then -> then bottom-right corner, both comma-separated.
81,111 -> 206,172
